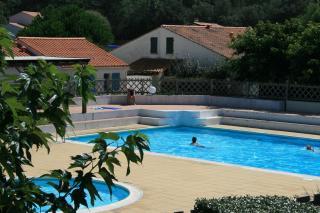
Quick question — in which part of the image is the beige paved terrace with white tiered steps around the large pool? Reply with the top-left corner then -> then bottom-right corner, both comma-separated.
28,95 -> 320,212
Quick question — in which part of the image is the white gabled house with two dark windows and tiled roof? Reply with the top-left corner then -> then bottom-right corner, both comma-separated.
112,22 -> 246,76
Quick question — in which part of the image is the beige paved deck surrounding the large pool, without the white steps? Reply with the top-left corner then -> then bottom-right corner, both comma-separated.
27,125 -> 320,213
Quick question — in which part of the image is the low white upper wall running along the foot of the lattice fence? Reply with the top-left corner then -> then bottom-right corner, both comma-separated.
75,95 -> 320,114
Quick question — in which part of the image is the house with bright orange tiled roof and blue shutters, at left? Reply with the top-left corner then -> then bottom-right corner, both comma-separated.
13,37 -> 129,80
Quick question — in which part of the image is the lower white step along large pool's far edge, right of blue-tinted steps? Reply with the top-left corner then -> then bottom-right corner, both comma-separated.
221,117 -> 320,134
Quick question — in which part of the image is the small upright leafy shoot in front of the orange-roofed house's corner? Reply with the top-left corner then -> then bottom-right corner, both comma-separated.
74,65 -> 96,113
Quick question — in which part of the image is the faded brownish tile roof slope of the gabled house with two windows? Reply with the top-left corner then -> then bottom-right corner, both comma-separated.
161,23 -> 246,58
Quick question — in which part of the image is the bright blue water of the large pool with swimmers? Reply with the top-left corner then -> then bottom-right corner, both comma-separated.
69,127 -> 320,176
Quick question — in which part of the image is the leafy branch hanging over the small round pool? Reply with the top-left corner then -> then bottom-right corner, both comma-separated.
43,132 -> 149,212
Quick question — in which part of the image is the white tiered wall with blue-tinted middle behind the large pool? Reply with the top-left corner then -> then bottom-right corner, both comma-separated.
41,108 -> 320,135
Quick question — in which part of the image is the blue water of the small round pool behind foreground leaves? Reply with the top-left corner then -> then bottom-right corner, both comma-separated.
34,178 -> 129,212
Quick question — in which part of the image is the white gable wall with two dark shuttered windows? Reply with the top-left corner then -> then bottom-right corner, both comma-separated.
112,27 -> 225,64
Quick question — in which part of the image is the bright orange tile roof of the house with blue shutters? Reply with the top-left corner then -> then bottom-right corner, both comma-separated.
17,37 -> 128,67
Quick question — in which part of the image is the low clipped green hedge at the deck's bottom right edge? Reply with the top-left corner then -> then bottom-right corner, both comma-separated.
192,196 -> 320,213
